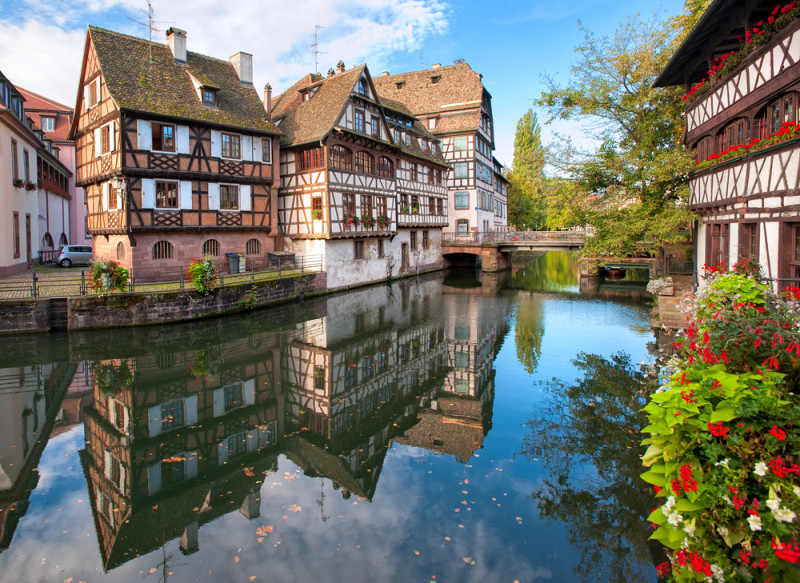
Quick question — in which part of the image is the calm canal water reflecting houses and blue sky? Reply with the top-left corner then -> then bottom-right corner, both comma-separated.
0,252 -> 663,583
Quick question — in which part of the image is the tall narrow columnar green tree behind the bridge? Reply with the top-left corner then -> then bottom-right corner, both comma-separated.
506,109 -> 547,229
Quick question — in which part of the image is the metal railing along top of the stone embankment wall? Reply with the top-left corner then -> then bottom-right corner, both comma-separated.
0,255 -> 323,300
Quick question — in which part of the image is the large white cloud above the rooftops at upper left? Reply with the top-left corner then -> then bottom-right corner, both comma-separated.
0,0 -> 451,105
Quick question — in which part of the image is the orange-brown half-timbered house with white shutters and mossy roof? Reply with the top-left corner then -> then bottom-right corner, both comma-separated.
70,27 -> 280,275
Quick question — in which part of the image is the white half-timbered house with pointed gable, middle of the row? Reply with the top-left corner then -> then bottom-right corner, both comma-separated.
271,61 -> 448,289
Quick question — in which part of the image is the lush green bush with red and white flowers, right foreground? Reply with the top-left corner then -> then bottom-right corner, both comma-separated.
642,272 -> 800,581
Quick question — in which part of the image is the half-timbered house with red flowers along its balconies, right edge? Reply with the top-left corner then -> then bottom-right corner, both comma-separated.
655,0 -> 800,285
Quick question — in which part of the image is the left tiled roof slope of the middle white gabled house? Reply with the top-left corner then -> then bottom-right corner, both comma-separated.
272,65 -> 366,145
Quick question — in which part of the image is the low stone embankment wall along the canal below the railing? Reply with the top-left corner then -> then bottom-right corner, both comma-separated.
0,273 -> 327,334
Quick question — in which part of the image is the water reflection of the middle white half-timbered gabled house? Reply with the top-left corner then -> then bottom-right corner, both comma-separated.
281,280 -> 447,498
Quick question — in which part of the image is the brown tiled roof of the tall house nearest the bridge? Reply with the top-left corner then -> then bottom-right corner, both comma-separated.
373,63 -> 484,122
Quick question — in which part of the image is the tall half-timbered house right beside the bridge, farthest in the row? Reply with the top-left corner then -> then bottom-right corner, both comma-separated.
375,63 -> 508,233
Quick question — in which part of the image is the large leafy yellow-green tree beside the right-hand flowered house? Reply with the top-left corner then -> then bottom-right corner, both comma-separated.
538,6 -> 701,256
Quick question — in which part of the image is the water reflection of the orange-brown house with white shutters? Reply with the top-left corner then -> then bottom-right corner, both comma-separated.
81,334 -> 282,570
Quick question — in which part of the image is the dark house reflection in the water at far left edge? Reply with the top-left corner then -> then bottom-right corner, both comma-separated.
0,363 -> 75,551
